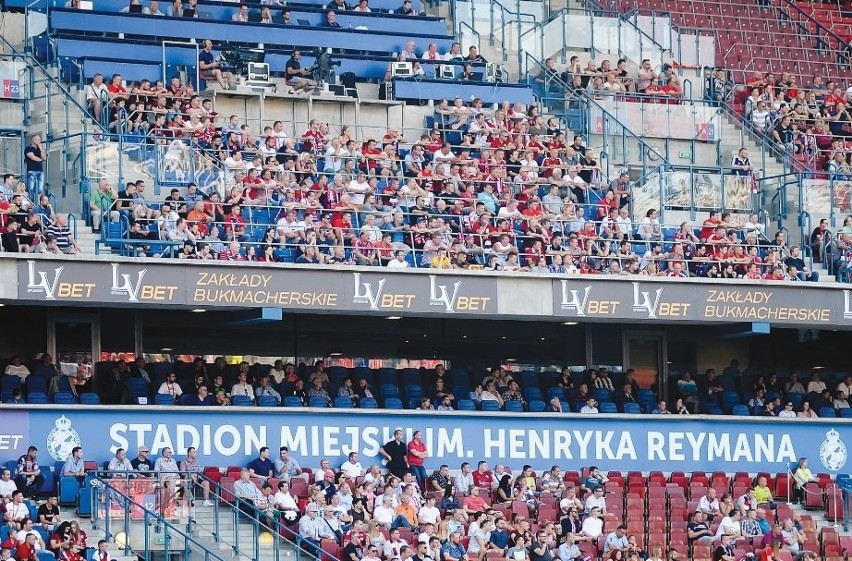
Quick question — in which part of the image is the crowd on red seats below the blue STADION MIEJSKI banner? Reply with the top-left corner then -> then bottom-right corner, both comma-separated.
75,430 -> 832,561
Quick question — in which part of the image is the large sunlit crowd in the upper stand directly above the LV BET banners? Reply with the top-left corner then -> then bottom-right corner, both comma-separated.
78,74 -> 818,280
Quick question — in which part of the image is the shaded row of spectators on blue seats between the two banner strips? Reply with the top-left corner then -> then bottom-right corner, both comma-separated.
5,355 -> 852,418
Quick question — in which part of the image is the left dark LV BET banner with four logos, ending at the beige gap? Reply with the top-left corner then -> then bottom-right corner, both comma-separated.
18,260 -> 497,314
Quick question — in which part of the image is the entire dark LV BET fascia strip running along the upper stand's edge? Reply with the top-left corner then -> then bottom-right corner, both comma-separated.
17,259 -> 852,327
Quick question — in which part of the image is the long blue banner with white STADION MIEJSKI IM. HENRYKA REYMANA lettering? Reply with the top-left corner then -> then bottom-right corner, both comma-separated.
10,406 -> 852,473
